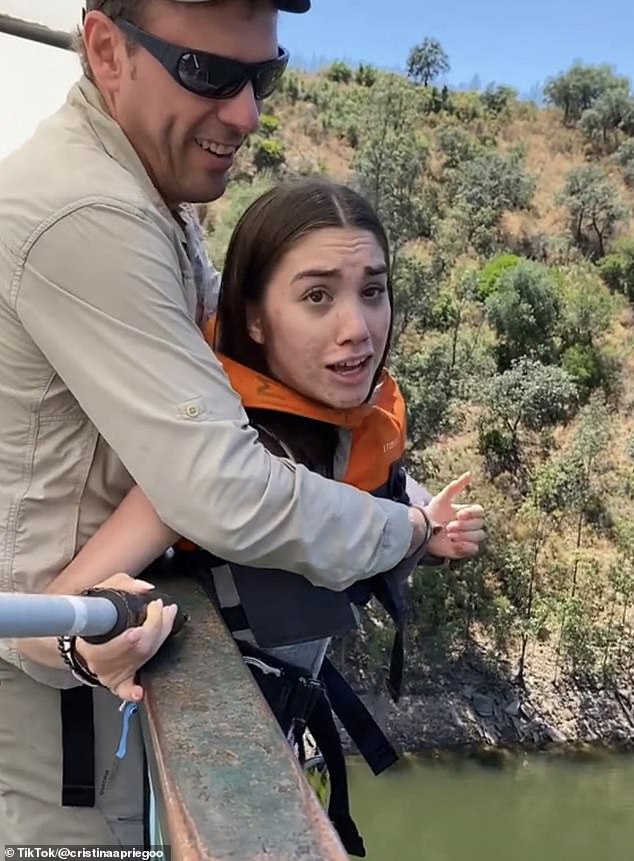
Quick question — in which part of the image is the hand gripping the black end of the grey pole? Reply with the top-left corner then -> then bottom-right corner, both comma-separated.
76,574 -> 177,703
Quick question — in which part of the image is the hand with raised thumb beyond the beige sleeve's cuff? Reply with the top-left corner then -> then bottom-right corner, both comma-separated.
423,472 -> 486,559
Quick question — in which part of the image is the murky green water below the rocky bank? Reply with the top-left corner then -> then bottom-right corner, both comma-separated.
349,754 -> 634,861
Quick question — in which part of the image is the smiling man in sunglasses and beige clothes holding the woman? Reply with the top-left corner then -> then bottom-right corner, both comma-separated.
0,0 -> 478,845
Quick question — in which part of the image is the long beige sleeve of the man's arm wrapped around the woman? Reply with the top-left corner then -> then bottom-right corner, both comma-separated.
13,203 -> 412,589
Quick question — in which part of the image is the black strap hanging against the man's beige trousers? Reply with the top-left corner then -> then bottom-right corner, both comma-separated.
60,685 -> 95,807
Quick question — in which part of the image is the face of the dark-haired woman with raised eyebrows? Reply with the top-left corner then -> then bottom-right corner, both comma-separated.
248,227 -> 391,409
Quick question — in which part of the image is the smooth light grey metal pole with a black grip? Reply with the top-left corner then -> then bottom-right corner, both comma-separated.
0,592 -> 118,638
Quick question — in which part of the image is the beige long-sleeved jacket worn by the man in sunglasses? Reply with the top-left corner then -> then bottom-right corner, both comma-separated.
0,79 -> 412,686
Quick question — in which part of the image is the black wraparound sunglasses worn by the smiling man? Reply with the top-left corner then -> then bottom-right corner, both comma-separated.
114,18 -> 288,101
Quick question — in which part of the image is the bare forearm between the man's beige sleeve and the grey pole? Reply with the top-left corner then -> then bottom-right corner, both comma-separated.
45,487 -> 179,595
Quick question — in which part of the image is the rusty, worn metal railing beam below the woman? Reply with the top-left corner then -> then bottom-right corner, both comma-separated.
140,573 -> 348,861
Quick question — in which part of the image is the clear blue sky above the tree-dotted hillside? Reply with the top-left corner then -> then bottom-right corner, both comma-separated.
280,0 -> 634,94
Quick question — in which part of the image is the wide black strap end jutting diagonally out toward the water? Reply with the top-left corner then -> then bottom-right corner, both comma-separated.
320,658 -> 399,774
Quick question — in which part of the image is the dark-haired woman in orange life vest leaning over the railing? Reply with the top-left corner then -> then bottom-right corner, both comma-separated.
27,179 -> 484,854
